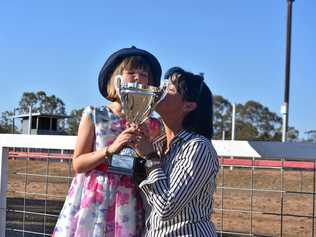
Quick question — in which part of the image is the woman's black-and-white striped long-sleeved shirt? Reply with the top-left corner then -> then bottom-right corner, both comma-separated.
139,130 -> 219,237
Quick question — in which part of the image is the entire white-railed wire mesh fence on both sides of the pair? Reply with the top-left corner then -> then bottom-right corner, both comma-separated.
0,135 -> 316,237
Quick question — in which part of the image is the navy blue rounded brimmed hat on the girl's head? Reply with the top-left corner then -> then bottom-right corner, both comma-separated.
98,46 -> 161,99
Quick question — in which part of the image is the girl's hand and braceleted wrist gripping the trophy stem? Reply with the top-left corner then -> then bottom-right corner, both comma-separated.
107,126 -> 137,154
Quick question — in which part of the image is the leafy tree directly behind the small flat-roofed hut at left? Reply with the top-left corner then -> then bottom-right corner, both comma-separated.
19,91 -> 66,115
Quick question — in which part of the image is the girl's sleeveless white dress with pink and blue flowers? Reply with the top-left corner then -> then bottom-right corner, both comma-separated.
53,106 -> 144,237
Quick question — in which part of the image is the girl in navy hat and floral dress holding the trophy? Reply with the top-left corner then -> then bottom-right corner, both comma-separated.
53,47 -> 161,237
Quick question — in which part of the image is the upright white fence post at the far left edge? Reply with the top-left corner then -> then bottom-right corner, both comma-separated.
0,146 -> 9,237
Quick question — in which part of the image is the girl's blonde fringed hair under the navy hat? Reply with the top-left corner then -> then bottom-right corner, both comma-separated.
106,56 -> 154,101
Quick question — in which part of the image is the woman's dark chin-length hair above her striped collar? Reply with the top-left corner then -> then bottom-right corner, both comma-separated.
165,67 -> 213,139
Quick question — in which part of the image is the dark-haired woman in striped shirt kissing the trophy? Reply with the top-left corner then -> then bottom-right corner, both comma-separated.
135,67 -> 218,237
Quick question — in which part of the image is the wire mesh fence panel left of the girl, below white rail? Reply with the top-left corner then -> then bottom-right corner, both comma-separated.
6,149 -> 73,236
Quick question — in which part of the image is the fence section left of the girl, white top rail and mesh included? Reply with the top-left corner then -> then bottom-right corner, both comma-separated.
0,135 -> 75,237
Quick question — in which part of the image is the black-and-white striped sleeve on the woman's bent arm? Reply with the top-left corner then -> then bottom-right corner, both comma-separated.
140,140 -> 218,220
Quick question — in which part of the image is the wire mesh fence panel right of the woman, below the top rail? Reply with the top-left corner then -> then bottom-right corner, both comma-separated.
213,157 -> 315,237
